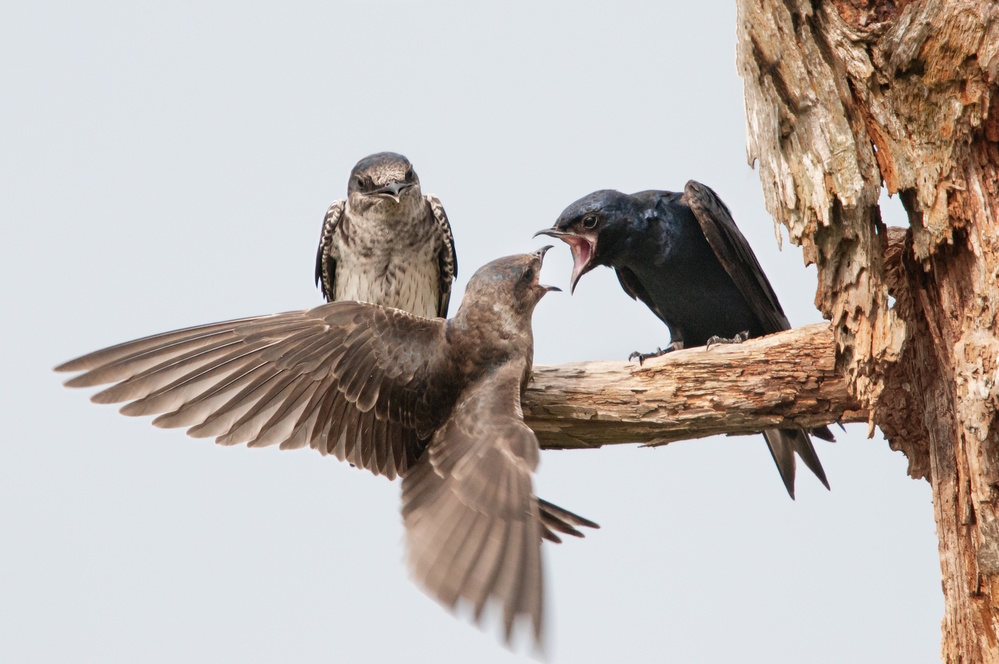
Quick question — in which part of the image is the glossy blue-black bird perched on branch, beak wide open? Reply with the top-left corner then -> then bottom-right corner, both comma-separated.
536,180 -> 834,499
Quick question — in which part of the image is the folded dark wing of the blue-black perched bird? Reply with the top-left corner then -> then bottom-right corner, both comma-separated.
680,180 -> 791,334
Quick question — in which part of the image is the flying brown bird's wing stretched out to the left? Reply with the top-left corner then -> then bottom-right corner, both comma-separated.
56,302 -> 454,478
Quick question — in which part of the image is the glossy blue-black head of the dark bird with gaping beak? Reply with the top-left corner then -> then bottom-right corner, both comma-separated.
534,189 -> 631,293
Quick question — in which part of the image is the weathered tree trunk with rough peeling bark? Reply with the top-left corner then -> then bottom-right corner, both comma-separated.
737,0 -> 999,663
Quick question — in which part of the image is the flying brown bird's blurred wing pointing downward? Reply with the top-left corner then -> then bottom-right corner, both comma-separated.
402,362 -> 558,640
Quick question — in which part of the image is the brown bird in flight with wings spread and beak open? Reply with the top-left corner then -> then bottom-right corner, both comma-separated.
55,247 -> 598,646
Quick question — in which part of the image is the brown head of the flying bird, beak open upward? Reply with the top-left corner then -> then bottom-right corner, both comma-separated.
462,245 -> 561,318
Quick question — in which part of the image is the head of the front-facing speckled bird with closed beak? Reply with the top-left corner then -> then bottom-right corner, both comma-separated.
347,152 -> 423,214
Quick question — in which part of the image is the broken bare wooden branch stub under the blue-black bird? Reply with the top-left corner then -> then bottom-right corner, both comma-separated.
523,323 -> 868,449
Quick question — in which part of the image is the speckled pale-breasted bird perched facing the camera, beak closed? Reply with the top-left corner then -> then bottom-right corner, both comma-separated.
316,152 -> 458,318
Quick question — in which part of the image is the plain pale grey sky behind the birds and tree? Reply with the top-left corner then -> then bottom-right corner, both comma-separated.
0,1 -> 943,664
